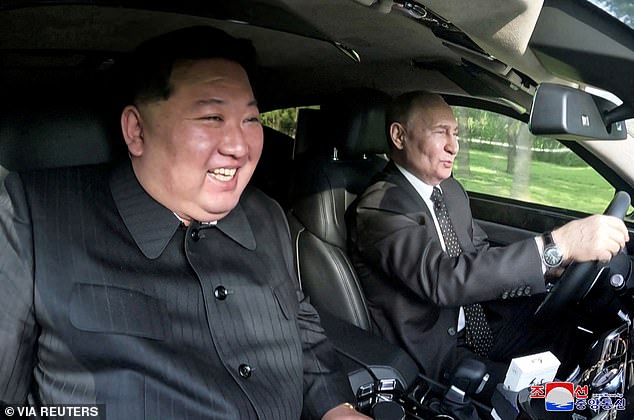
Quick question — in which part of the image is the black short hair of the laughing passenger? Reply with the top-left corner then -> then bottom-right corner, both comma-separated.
130,26 -> 256,105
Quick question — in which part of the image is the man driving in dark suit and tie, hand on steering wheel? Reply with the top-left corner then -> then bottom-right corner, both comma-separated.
348,92 -> 628,398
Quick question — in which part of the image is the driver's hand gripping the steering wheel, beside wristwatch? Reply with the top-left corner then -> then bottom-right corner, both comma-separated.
552,215 -> 629,262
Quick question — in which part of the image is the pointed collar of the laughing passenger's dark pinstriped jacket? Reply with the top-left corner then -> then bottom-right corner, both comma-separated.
110,160 -> 256,259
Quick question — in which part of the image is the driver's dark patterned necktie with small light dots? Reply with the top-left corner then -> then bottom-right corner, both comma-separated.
431,187 -> 493,356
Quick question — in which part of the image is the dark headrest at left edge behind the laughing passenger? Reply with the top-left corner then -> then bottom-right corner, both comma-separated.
0,104 -> 125,171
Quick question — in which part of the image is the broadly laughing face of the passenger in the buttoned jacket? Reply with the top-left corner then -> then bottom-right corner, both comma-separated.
124,59 -> 262,221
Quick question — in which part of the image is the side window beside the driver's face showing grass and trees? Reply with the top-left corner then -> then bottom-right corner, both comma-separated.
453,107 -> 614,213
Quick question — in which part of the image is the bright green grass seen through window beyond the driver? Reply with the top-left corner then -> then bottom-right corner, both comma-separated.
454,150 -> 614,213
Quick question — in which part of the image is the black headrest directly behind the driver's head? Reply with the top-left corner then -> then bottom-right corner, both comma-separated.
322,89 -> 390,156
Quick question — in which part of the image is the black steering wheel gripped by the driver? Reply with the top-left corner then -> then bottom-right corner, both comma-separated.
535,191 -> 631,319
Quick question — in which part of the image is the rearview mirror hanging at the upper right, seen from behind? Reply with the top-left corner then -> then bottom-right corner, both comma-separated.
528,83 -> 627,140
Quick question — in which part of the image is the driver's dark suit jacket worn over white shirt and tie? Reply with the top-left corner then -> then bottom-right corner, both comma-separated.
348,162 -> 545,378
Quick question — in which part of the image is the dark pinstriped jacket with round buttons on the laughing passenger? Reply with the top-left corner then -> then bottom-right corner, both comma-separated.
0,163 -> 351,420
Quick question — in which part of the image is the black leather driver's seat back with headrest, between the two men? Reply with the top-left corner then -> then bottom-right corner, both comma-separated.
289,90 -> 389,330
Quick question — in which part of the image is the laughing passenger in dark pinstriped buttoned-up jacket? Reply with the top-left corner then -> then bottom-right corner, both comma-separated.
0,27 -> 367,420
